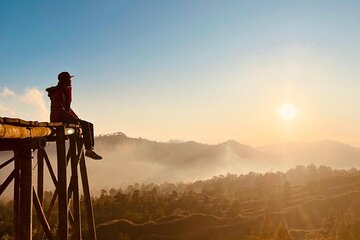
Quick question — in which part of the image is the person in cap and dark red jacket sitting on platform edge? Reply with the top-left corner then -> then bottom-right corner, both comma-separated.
46,72 -> 102,160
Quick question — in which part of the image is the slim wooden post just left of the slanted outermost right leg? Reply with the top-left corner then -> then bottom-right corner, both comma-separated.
70,136 -> 81,240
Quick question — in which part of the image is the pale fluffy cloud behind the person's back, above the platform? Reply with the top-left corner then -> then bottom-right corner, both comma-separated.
0,87 -> 49,121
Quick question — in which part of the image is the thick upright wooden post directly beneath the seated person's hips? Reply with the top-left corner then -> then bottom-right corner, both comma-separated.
56,126 -> 68,240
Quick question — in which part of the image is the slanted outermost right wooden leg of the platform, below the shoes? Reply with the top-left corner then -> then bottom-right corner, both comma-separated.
78,138 -> 96,240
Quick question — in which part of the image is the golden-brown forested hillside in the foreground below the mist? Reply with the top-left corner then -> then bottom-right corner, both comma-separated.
0,165 -> 360,240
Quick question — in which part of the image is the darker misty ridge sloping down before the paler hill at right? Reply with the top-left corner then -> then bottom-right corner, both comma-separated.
83,133 -> 276,188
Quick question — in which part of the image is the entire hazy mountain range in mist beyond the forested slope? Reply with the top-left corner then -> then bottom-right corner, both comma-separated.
0,132 -> 360,194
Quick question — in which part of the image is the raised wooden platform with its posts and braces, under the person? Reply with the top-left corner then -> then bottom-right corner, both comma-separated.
0,117 -> 96,240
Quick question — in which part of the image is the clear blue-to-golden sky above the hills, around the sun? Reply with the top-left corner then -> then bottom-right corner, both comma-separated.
0,0 -> 360,146
